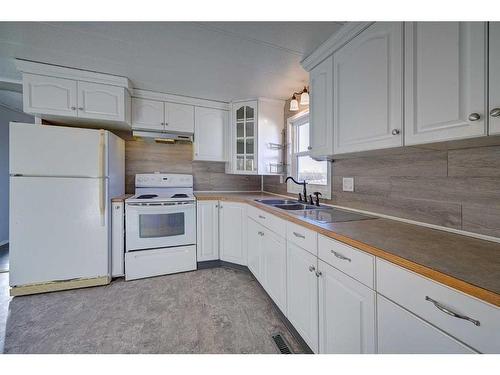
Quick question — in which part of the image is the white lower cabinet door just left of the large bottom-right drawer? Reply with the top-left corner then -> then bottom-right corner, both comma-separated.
318,260 -> 376,354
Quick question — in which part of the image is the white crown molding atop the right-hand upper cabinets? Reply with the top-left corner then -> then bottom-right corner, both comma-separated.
300,22 -> 375,71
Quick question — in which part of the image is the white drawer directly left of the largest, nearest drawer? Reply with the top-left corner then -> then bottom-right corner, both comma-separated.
318,235 -> 375,289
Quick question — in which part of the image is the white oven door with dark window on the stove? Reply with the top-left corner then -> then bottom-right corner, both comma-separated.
125,202 -> 196,251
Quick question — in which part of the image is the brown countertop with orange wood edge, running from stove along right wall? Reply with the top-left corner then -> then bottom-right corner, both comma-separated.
195,193 -> 500,306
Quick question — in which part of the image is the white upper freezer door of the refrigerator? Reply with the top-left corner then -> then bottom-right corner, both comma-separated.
9,122 -> 108,177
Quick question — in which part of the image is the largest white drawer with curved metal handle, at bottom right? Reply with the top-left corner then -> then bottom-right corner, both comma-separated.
377,259 -> 500,353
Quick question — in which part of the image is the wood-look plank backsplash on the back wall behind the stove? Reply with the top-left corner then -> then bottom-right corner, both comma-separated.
124,134 -> 261,193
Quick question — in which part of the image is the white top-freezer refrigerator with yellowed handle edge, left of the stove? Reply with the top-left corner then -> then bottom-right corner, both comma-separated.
9,123 -> 125,287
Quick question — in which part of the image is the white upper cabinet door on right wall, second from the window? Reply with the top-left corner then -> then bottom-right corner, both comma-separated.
333,22 -> 403,154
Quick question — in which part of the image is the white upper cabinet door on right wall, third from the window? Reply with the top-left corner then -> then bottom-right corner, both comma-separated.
405,22 -> 486,145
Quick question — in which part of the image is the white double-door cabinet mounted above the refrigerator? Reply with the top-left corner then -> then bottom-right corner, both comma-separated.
16,60 -> 131,130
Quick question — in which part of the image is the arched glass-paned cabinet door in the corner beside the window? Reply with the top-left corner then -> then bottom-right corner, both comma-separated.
233,101 -> 257,173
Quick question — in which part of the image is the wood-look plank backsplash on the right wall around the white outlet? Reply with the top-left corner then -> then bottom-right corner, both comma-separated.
264,146 -> 500,237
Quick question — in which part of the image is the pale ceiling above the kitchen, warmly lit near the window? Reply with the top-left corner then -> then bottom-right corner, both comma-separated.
0,22 -> 342,107
